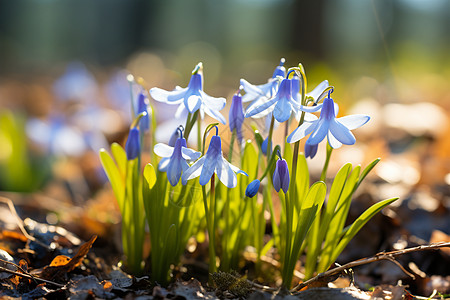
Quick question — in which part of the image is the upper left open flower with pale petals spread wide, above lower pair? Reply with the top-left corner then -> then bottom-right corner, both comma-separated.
150,63 -> 226,124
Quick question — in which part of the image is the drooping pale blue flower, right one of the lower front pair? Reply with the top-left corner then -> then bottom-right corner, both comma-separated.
181,126 -> 248,188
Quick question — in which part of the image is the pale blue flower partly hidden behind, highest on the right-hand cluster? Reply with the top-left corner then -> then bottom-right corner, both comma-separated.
240,58 -> 286,102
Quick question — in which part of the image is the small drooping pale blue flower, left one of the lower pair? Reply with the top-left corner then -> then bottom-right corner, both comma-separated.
153,128 -> 201,186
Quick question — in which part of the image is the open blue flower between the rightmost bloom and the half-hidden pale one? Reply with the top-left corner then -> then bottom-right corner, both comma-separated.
245,78 -> 322,123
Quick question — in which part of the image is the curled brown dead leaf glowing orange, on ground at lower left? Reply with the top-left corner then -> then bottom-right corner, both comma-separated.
39,235 -> 97,280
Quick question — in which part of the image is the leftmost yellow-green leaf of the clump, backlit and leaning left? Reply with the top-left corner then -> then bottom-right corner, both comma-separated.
99,149 -> 125,213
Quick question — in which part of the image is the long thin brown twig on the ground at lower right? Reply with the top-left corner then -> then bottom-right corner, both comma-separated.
290,242 -> 450,293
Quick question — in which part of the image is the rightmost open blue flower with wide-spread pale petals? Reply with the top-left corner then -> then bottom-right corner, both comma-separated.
287,93 -> 370,148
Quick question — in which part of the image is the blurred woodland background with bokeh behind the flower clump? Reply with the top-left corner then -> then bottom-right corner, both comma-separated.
0,0 -> 450,292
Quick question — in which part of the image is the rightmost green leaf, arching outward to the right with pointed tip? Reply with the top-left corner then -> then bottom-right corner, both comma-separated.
332,198 -> 398,261
